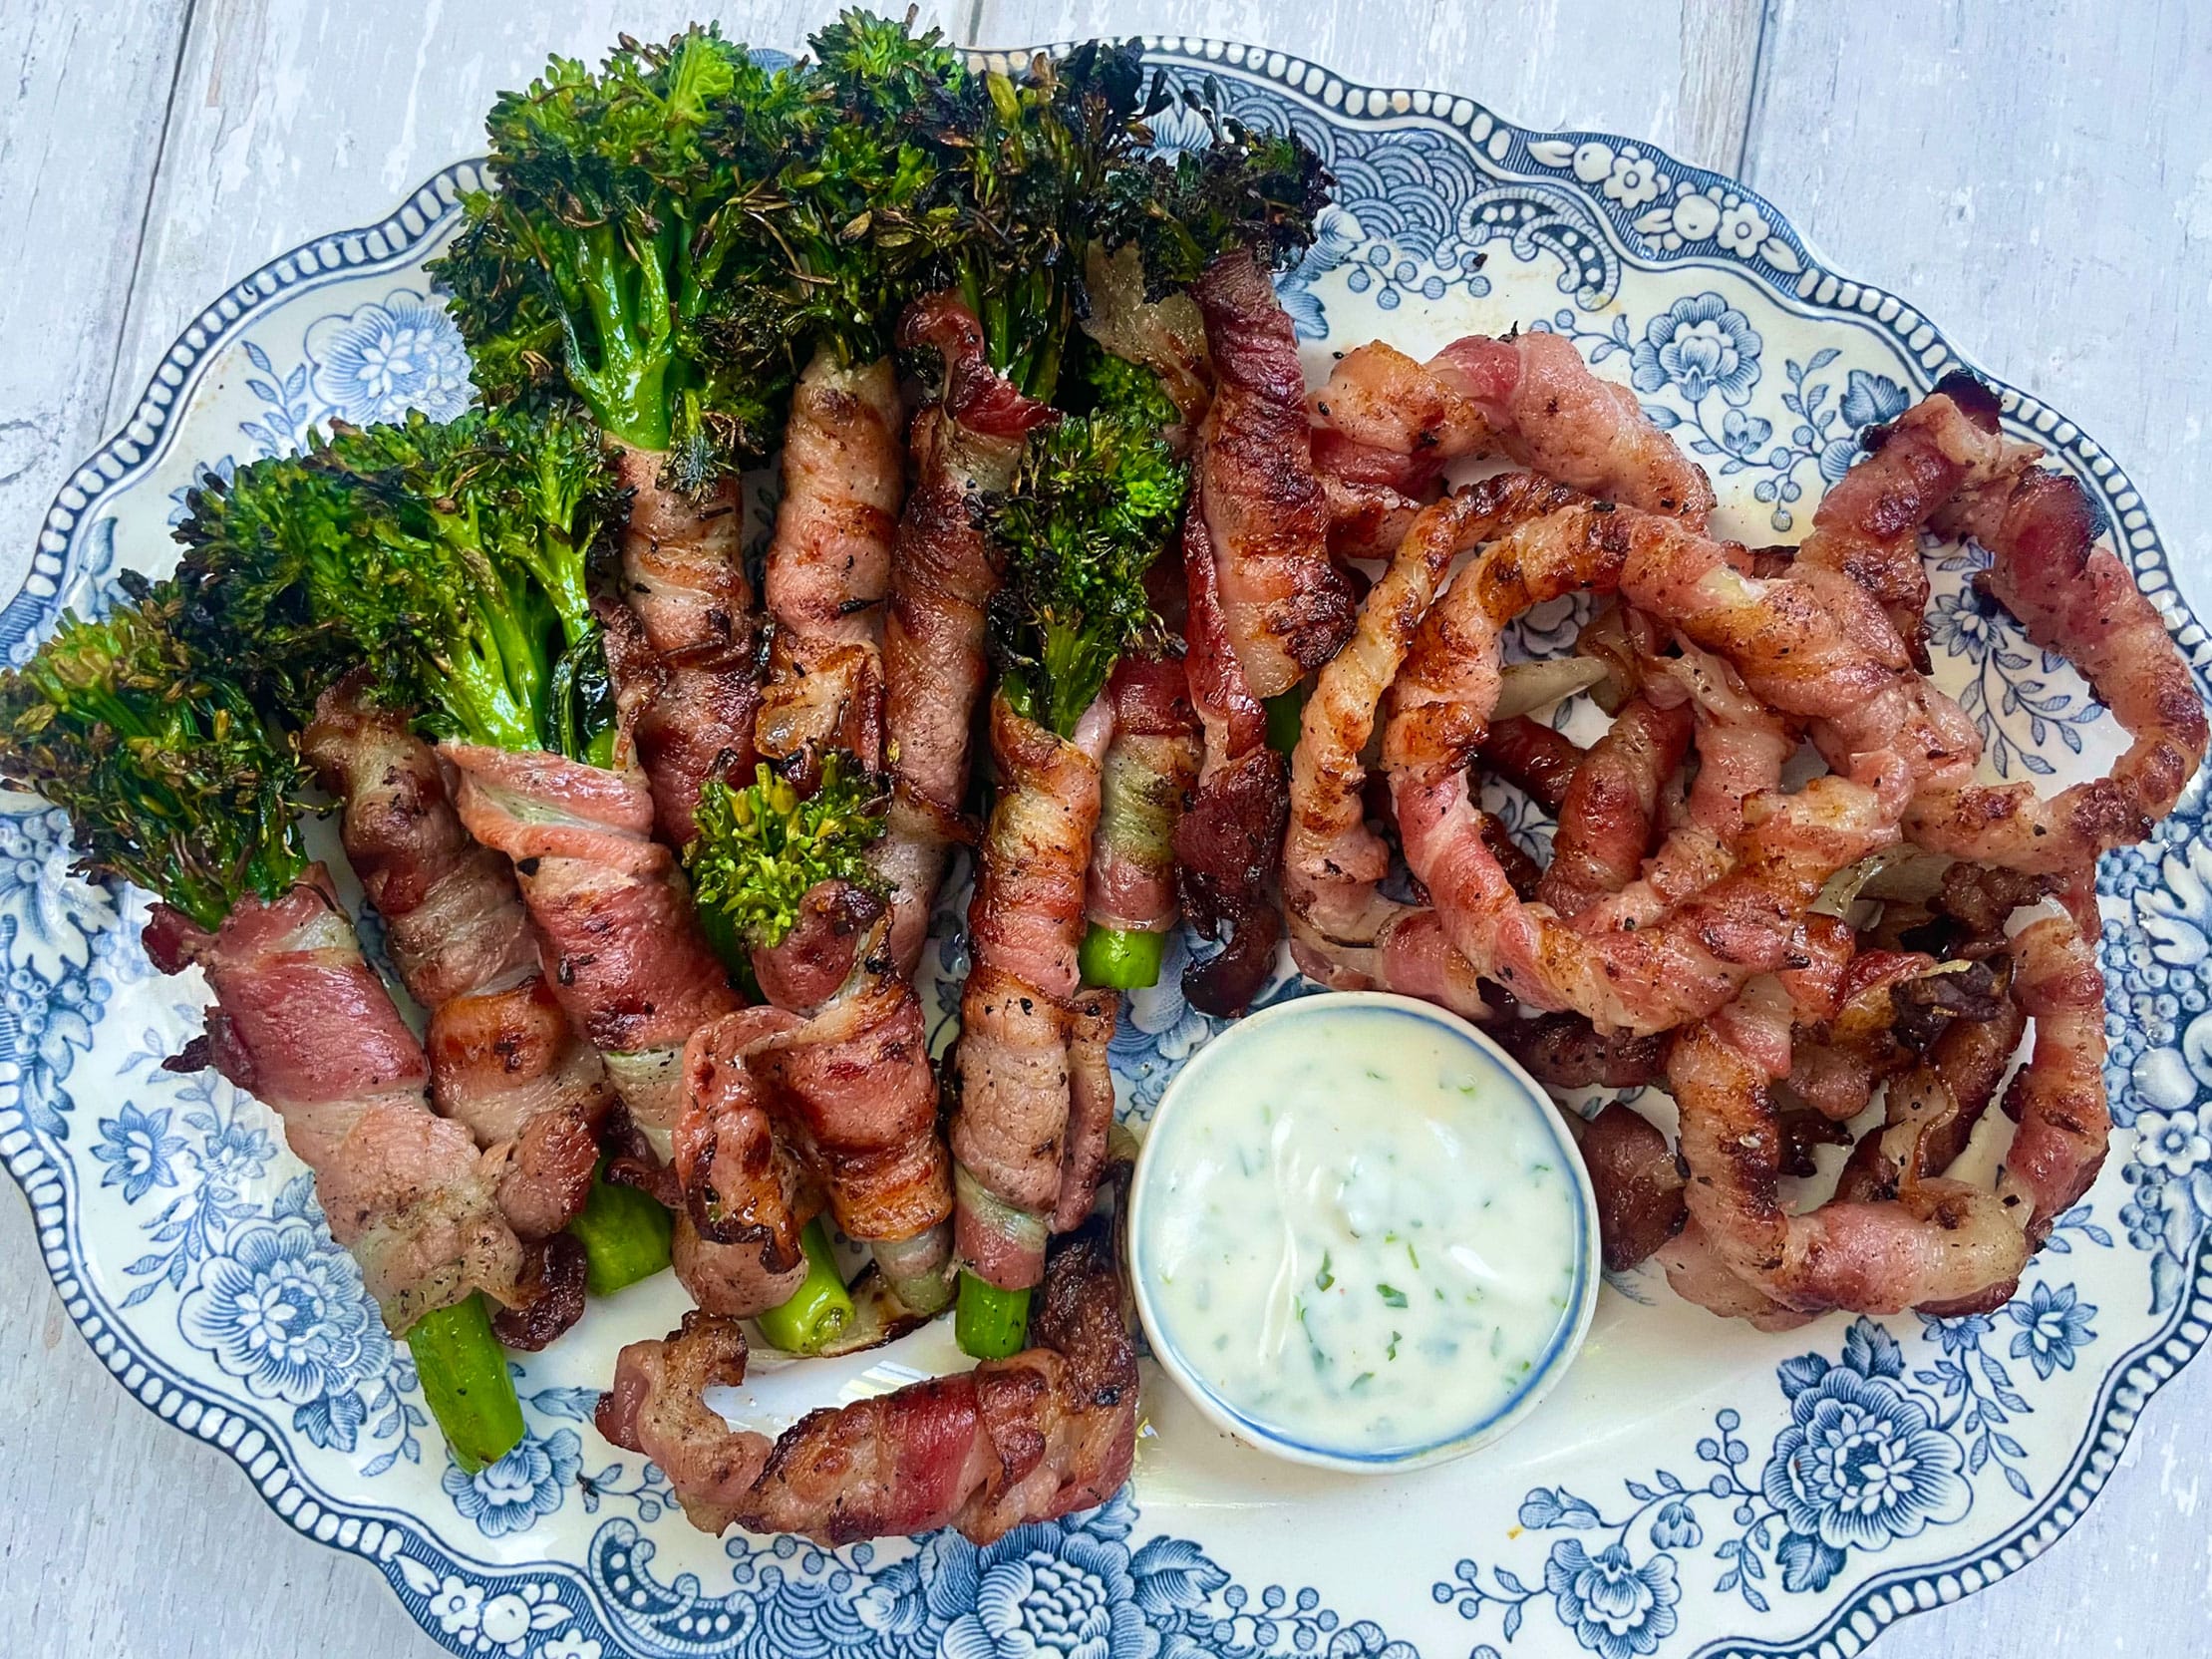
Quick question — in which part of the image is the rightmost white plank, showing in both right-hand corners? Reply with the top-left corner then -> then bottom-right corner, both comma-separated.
1743,0 -> 2212,1659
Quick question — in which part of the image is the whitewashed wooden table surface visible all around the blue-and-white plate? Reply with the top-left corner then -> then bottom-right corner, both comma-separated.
0,0 -> 2212,1659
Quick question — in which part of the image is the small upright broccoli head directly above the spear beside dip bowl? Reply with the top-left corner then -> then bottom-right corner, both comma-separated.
991,409 -> 1190,737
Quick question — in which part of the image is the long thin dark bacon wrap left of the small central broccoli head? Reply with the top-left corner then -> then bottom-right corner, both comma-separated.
876,292 -> 1060,973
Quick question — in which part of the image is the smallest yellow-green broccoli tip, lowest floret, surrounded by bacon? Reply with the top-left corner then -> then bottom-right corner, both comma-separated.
684,750 -> 889,949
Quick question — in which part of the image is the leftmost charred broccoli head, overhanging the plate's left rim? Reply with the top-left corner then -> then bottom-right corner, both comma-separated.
0,573 -> 310,931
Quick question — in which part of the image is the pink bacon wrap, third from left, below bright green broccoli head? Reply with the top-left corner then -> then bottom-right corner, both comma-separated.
441,739 -> 739,1155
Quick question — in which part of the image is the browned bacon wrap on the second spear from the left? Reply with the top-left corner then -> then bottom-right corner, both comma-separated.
301,677 -> 615,1238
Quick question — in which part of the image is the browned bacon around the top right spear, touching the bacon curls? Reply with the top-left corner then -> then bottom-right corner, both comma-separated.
1192,250 -> 1352,697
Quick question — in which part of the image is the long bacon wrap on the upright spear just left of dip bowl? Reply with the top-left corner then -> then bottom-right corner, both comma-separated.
951,695 -> 1112,1289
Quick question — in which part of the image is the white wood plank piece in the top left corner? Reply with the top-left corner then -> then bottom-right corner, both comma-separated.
0,0 -> 185,593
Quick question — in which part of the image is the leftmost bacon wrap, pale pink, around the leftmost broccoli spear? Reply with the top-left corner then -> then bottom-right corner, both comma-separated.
146,864 -> 522,1332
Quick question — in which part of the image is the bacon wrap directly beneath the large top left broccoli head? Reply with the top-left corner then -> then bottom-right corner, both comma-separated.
615,443 -> 761,847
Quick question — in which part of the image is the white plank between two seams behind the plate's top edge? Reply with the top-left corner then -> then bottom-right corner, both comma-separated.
976,0 -> 1758,166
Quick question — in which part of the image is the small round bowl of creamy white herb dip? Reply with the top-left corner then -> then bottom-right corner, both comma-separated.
1128,991 -> 1599,1474
